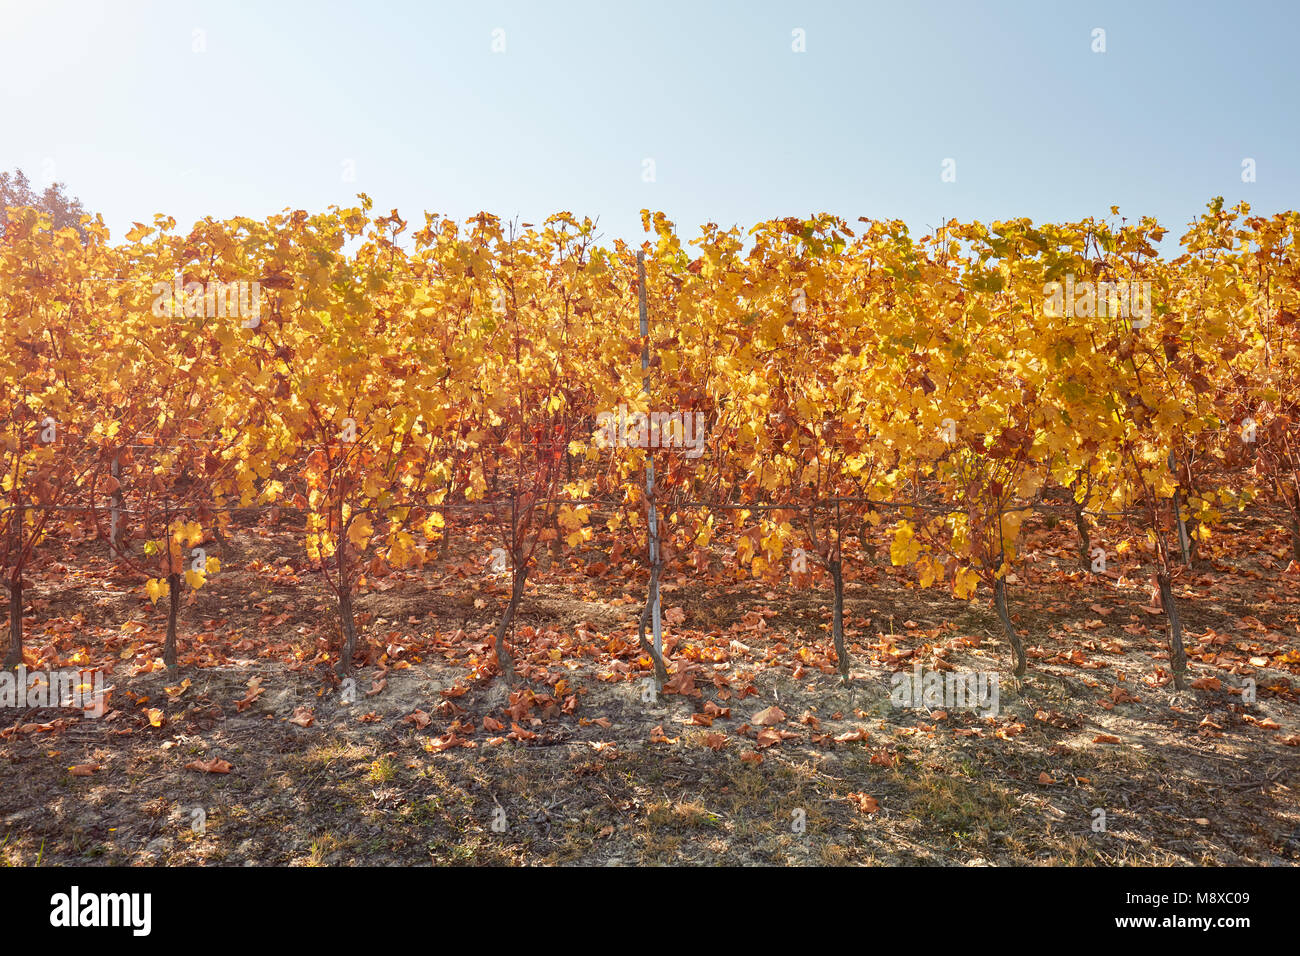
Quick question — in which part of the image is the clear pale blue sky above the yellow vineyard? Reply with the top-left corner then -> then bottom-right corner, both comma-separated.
0,0 -> 1300,247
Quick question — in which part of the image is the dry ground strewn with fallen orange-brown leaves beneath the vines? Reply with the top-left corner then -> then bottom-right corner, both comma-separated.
0,522 -> 1300,865
